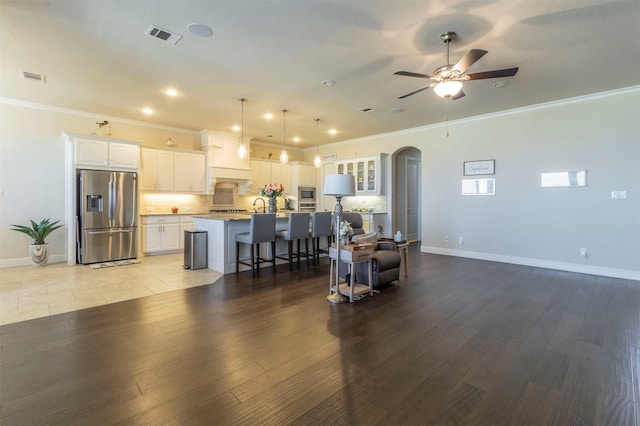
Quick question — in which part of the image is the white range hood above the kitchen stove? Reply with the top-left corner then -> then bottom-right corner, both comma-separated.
200,130 -> 252,194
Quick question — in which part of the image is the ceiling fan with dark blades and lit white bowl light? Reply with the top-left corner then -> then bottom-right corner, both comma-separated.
394,31 -> 518,100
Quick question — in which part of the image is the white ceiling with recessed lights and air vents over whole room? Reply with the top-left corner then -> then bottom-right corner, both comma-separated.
0,0 -> 640,147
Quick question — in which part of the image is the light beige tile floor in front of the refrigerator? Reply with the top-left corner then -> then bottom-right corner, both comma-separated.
0,253 -> 222,325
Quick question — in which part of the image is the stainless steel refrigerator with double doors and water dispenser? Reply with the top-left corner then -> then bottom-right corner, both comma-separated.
77,170 -> 138,264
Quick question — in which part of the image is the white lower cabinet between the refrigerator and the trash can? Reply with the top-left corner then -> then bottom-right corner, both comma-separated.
140,215 -> 193,254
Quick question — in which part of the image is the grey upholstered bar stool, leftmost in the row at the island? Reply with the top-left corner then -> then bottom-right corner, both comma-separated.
236,213 -> 276,277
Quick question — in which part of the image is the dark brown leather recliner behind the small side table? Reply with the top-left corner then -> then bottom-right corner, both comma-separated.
342,213 -> 401,287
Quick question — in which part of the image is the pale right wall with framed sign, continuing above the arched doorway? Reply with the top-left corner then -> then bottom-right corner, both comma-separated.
306,87 -> 640,279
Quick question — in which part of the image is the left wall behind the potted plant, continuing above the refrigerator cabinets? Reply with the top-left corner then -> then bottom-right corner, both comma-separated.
0,99 -> 200,267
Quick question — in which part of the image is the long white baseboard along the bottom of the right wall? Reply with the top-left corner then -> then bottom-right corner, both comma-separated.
420,246 -> 640,281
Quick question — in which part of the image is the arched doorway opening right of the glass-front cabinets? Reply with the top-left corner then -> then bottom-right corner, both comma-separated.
393,147 -> 422,241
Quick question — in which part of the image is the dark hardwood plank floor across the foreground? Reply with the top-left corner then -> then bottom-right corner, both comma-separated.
0,247 -> 640,426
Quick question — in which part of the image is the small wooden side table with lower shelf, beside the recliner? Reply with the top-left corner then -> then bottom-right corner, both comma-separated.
329,244 -> 373,303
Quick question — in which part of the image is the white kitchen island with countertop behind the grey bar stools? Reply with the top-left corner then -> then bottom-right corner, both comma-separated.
193,213 -> 302,274
